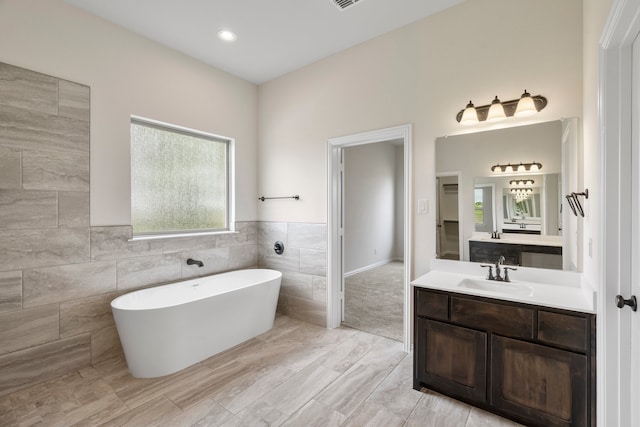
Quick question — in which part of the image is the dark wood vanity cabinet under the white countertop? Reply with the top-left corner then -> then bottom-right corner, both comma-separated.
413,287 -> 596,427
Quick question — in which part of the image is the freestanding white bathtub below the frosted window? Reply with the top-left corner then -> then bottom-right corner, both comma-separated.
111,269 -> 282,378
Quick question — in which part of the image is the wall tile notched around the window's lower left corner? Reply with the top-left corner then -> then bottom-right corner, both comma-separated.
91,225 -> 163,261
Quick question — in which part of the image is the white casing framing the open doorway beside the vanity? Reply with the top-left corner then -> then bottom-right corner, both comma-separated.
327,125 -> 412,351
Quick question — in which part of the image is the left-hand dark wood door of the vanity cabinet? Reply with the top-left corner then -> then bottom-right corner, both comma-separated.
415,317 -> 487,403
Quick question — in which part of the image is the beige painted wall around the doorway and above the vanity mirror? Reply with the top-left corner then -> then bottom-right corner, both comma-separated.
258,0 -> 583,277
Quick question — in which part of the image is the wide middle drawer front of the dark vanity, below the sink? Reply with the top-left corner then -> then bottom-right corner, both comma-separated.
451,297 -> 534,339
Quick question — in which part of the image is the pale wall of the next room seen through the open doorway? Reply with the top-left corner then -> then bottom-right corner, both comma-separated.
344,143 -> 403,273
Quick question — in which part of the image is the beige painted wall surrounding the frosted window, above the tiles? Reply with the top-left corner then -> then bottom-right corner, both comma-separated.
0,0 -> 257,226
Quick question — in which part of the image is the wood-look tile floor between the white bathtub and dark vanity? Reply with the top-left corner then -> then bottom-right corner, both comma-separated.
0,316 -> 517,427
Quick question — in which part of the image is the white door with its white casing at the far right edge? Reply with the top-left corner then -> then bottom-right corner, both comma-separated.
597,0 -> 640,427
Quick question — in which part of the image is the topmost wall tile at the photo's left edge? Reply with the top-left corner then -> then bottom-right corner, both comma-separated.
0,62 -> 58,114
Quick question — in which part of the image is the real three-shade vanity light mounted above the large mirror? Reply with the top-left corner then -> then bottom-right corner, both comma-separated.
456,89 -> 547,125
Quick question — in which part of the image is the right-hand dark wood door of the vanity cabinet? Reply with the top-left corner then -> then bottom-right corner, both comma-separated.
491,335 -> 588,427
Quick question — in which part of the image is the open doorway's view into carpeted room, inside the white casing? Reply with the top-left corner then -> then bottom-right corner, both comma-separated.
342,140 -> 404,341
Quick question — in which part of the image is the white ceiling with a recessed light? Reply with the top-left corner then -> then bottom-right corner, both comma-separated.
65,0 -> 463,84
